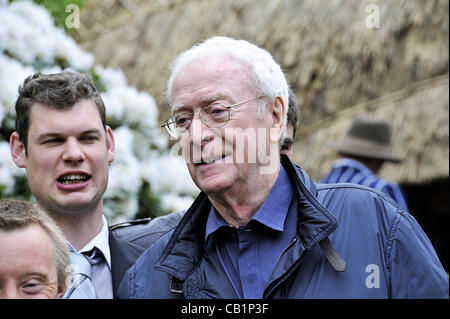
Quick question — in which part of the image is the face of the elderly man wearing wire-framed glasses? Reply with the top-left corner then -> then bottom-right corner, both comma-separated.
172,56 -> 284,193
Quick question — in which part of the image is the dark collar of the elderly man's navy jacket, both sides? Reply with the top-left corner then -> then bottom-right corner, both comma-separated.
155,154 -> 337,281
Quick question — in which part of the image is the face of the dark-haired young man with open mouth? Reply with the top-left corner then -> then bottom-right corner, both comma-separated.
11,100 -> 114,215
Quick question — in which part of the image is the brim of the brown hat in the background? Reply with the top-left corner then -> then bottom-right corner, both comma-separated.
330,137 -> 403,163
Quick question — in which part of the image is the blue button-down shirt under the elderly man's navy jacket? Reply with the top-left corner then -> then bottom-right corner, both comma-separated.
205,167 -> 297,299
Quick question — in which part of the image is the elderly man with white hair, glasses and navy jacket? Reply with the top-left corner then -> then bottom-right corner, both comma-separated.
118,37 -> 448,299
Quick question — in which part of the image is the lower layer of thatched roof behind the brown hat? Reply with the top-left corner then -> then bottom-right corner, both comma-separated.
294,74 -> 449,183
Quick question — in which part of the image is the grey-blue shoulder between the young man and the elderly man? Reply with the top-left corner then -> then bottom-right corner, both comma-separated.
110,211 -> 185,248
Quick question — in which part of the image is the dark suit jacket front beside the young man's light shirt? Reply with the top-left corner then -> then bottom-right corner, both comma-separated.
109,230 -> 145,296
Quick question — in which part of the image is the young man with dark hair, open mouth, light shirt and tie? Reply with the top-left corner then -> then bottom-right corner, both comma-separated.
10,71 -> 144,299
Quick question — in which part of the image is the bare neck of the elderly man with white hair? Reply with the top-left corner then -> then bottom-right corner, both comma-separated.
207,162 -> 280,226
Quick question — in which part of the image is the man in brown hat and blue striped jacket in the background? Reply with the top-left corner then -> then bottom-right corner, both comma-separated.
321,116 -> 408,210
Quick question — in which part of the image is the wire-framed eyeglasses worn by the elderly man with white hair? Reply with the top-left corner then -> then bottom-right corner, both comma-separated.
161,95 -> 264,139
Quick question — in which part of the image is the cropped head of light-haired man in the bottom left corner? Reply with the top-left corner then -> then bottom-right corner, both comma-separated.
0,199 -> 70,299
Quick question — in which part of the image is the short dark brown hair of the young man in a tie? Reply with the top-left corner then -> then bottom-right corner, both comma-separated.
16,71 -> 106,151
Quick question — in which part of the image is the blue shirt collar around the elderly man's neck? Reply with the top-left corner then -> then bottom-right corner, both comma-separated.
205,166 -> 293,239
